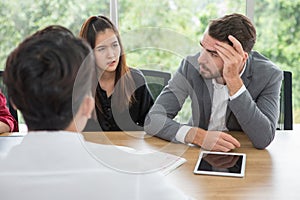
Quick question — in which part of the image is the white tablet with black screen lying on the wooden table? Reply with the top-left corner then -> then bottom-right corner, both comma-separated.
194,151 -> 246,177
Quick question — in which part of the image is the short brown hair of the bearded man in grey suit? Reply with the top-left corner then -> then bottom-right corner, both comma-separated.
208,13 -> 256,53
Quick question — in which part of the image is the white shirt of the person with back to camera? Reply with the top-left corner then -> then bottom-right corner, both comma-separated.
0,131 -> 188,200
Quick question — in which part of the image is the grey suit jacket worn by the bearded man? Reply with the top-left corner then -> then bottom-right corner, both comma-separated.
144,51 -> 283,149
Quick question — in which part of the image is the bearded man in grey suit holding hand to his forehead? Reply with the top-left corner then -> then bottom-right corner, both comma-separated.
145,14 -> 283,151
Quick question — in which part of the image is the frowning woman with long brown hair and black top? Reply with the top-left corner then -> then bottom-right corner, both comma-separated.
79,16 -> 153,131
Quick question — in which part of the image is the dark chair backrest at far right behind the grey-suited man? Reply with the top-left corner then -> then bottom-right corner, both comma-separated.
277,71 -> 293,130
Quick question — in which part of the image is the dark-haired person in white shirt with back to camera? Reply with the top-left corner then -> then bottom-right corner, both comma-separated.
0,26 -> 188,200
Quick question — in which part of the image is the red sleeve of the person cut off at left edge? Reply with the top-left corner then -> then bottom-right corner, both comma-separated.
0,91 -> 19,132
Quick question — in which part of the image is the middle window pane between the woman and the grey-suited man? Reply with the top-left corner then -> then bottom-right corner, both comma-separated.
118,0 -> 246,122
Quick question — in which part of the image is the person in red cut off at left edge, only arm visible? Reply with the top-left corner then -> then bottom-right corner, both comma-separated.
0,91 -> 18,133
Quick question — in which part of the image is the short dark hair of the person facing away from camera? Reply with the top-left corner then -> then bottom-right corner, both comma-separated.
4,25 -> 95,130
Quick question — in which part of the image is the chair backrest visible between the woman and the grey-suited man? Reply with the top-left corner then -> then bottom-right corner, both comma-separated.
141,69 -> 171,100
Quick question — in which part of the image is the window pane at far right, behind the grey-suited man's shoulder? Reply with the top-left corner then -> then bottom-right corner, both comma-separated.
254,0 -> 300,124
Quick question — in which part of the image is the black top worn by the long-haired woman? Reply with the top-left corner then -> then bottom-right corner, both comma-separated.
84,68 -> 153,131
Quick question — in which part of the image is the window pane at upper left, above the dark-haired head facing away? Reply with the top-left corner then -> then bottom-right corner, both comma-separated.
0,0 -> 109,69
